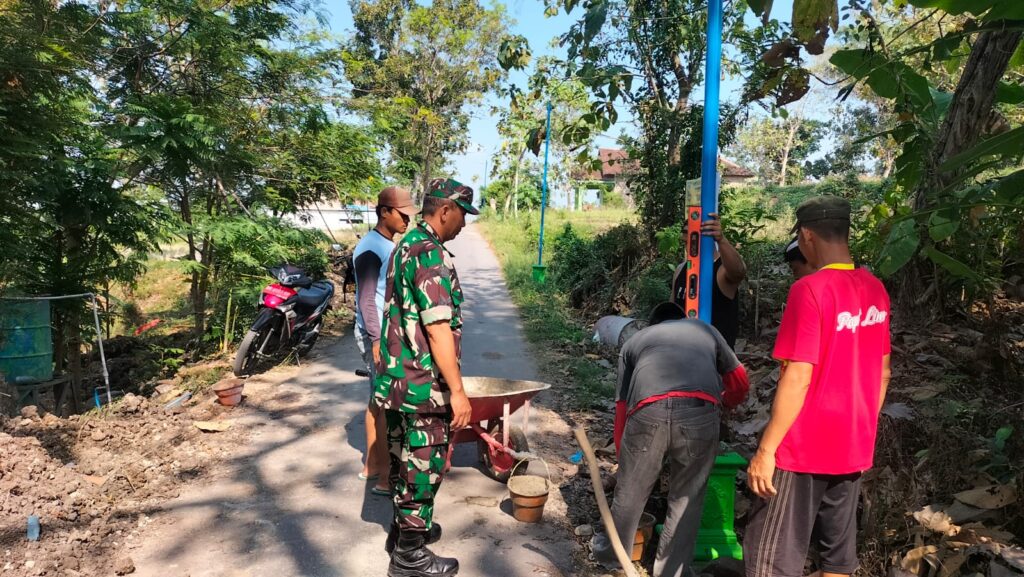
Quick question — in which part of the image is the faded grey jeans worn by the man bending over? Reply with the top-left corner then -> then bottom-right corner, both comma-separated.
592,398 -> 721,577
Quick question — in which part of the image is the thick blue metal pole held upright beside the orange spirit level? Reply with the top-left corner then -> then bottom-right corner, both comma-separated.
697,0 -> 722,323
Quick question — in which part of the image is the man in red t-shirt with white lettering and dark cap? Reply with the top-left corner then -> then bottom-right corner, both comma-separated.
743,197 -> 890,577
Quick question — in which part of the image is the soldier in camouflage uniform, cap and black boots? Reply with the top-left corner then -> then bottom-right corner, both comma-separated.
374,178 -> 478,577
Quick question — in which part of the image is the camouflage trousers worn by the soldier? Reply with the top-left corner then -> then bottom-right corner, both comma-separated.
384,410 -> 452,532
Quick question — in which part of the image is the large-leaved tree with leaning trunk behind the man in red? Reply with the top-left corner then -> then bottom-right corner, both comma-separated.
749,0 -> 1024,314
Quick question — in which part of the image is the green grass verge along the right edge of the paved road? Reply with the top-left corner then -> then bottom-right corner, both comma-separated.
477,210 -> 636,410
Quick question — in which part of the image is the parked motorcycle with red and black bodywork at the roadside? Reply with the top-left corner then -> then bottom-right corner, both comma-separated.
231,264 -> 334,377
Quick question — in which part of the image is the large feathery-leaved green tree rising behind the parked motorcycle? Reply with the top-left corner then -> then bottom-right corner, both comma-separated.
105,0 -> 378,335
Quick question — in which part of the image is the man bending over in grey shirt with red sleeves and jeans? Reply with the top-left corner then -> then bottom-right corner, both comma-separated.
591,302 -> 750,577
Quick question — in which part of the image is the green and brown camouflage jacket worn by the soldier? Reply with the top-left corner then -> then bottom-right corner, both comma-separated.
374,222 -> 463,413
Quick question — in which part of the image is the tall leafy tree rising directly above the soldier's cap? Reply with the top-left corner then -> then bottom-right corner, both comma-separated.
343,0 -> 510,190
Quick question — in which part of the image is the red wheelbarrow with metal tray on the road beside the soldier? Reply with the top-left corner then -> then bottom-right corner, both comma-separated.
445,377 -> 551,482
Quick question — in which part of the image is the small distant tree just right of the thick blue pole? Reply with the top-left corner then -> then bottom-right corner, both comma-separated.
734,110 -> 825,187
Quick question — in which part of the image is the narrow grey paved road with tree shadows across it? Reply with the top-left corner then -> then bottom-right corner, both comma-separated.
128,225 -> 573,577
